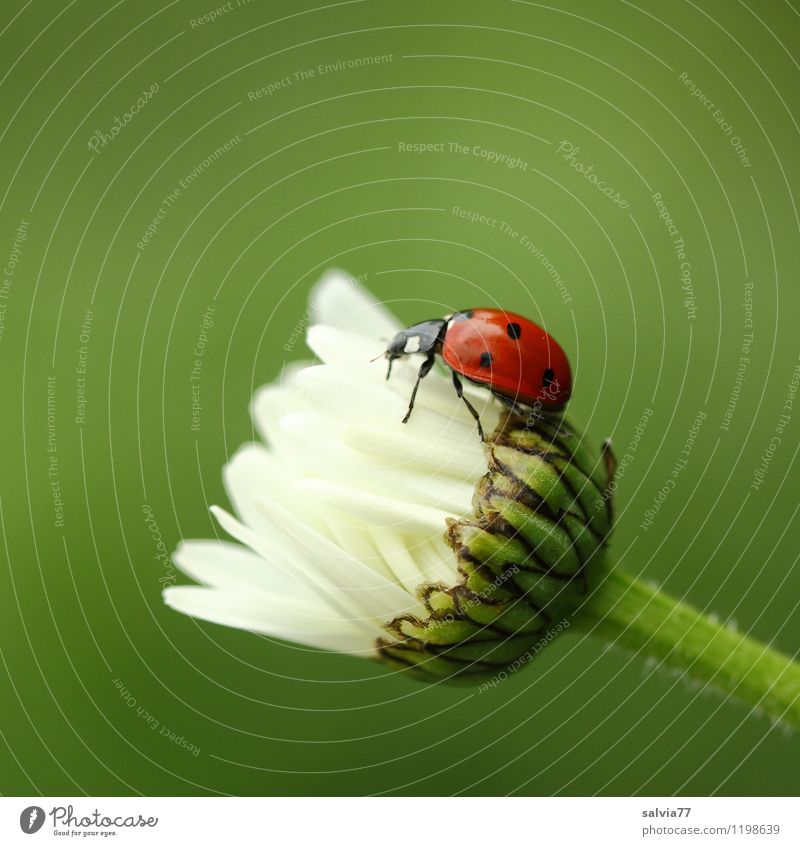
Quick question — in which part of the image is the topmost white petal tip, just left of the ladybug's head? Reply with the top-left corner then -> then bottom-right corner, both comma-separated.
310,270 -> 403,344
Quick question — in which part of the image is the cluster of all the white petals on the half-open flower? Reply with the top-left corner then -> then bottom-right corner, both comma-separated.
164,272 -> 499,656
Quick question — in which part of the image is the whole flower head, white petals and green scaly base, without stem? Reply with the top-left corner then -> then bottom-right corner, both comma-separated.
164,272 -> 610,678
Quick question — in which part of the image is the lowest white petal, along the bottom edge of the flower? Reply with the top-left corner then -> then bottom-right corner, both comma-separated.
164,586 -> 383,656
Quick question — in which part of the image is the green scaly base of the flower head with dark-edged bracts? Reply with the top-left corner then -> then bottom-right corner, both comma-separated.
377,412 -> 613,682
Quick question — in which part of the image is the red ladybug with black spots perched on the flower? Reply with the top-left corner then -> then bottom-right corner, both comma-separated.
384,308 -> 572,440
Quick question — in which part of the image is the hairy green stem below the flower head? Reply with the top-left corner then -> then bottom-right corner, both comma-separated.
576,564 -> 800,730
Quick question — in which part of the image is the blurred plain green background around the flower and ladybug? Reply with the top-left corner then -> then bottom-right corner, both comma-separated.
0,0 -> 800,795
